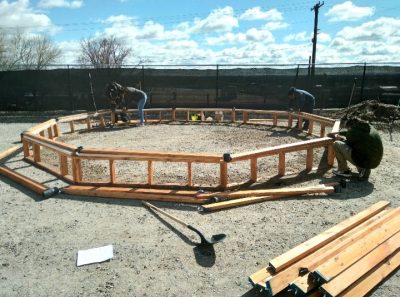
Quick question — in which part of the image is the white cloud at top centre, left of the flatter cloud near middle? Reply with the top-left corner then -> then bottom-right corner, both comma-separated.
191,6 -> 239,33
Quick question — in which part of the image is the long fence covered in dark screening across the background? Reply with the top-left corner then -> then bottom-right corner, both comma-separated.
0,63 -> 400,111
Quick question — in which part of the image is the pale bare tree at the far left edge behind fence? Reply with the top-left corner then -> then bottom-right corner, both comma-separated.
0,32 -> 61,70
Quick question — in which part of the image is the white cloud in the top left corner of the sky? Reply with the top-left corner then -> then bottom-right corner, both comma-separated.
0,0 -> 58,34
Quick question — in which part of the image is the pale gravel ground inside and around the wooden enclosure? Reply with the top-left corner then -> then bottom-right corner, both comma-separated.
0,114 -> 400,297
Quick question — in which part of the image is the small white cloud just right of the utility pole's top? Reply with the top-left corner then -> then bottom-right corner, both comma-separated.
325,1 -> 375,22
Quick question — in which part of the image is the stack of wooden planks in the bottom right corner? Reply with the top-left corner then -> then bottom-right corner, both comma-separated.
250,201 -> 400,296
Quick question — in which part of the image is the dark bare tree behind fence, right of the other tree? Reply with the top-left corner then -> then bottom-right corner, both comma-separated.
78,37 -> 132,67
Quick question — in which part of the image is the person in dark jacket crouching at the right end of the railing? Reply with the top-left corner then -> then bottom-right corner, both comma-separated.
333,118 -> 383,179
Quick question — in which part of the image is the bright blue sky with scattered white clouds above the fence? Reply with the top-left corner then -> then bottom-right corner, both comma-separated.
0,0 -> 400,64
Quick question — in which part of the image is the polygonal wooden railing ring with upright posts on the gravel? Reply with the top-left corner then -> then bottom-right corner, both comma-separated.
21,108 -> 340,188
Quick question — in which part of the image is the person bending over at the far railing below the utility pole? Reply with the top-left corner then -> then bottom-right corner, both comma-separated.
288,87 -> 315,130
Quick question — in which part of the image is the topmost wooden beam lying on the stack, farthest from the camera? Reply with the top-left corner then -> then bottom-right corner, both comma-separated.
269,201 -> 390,272
